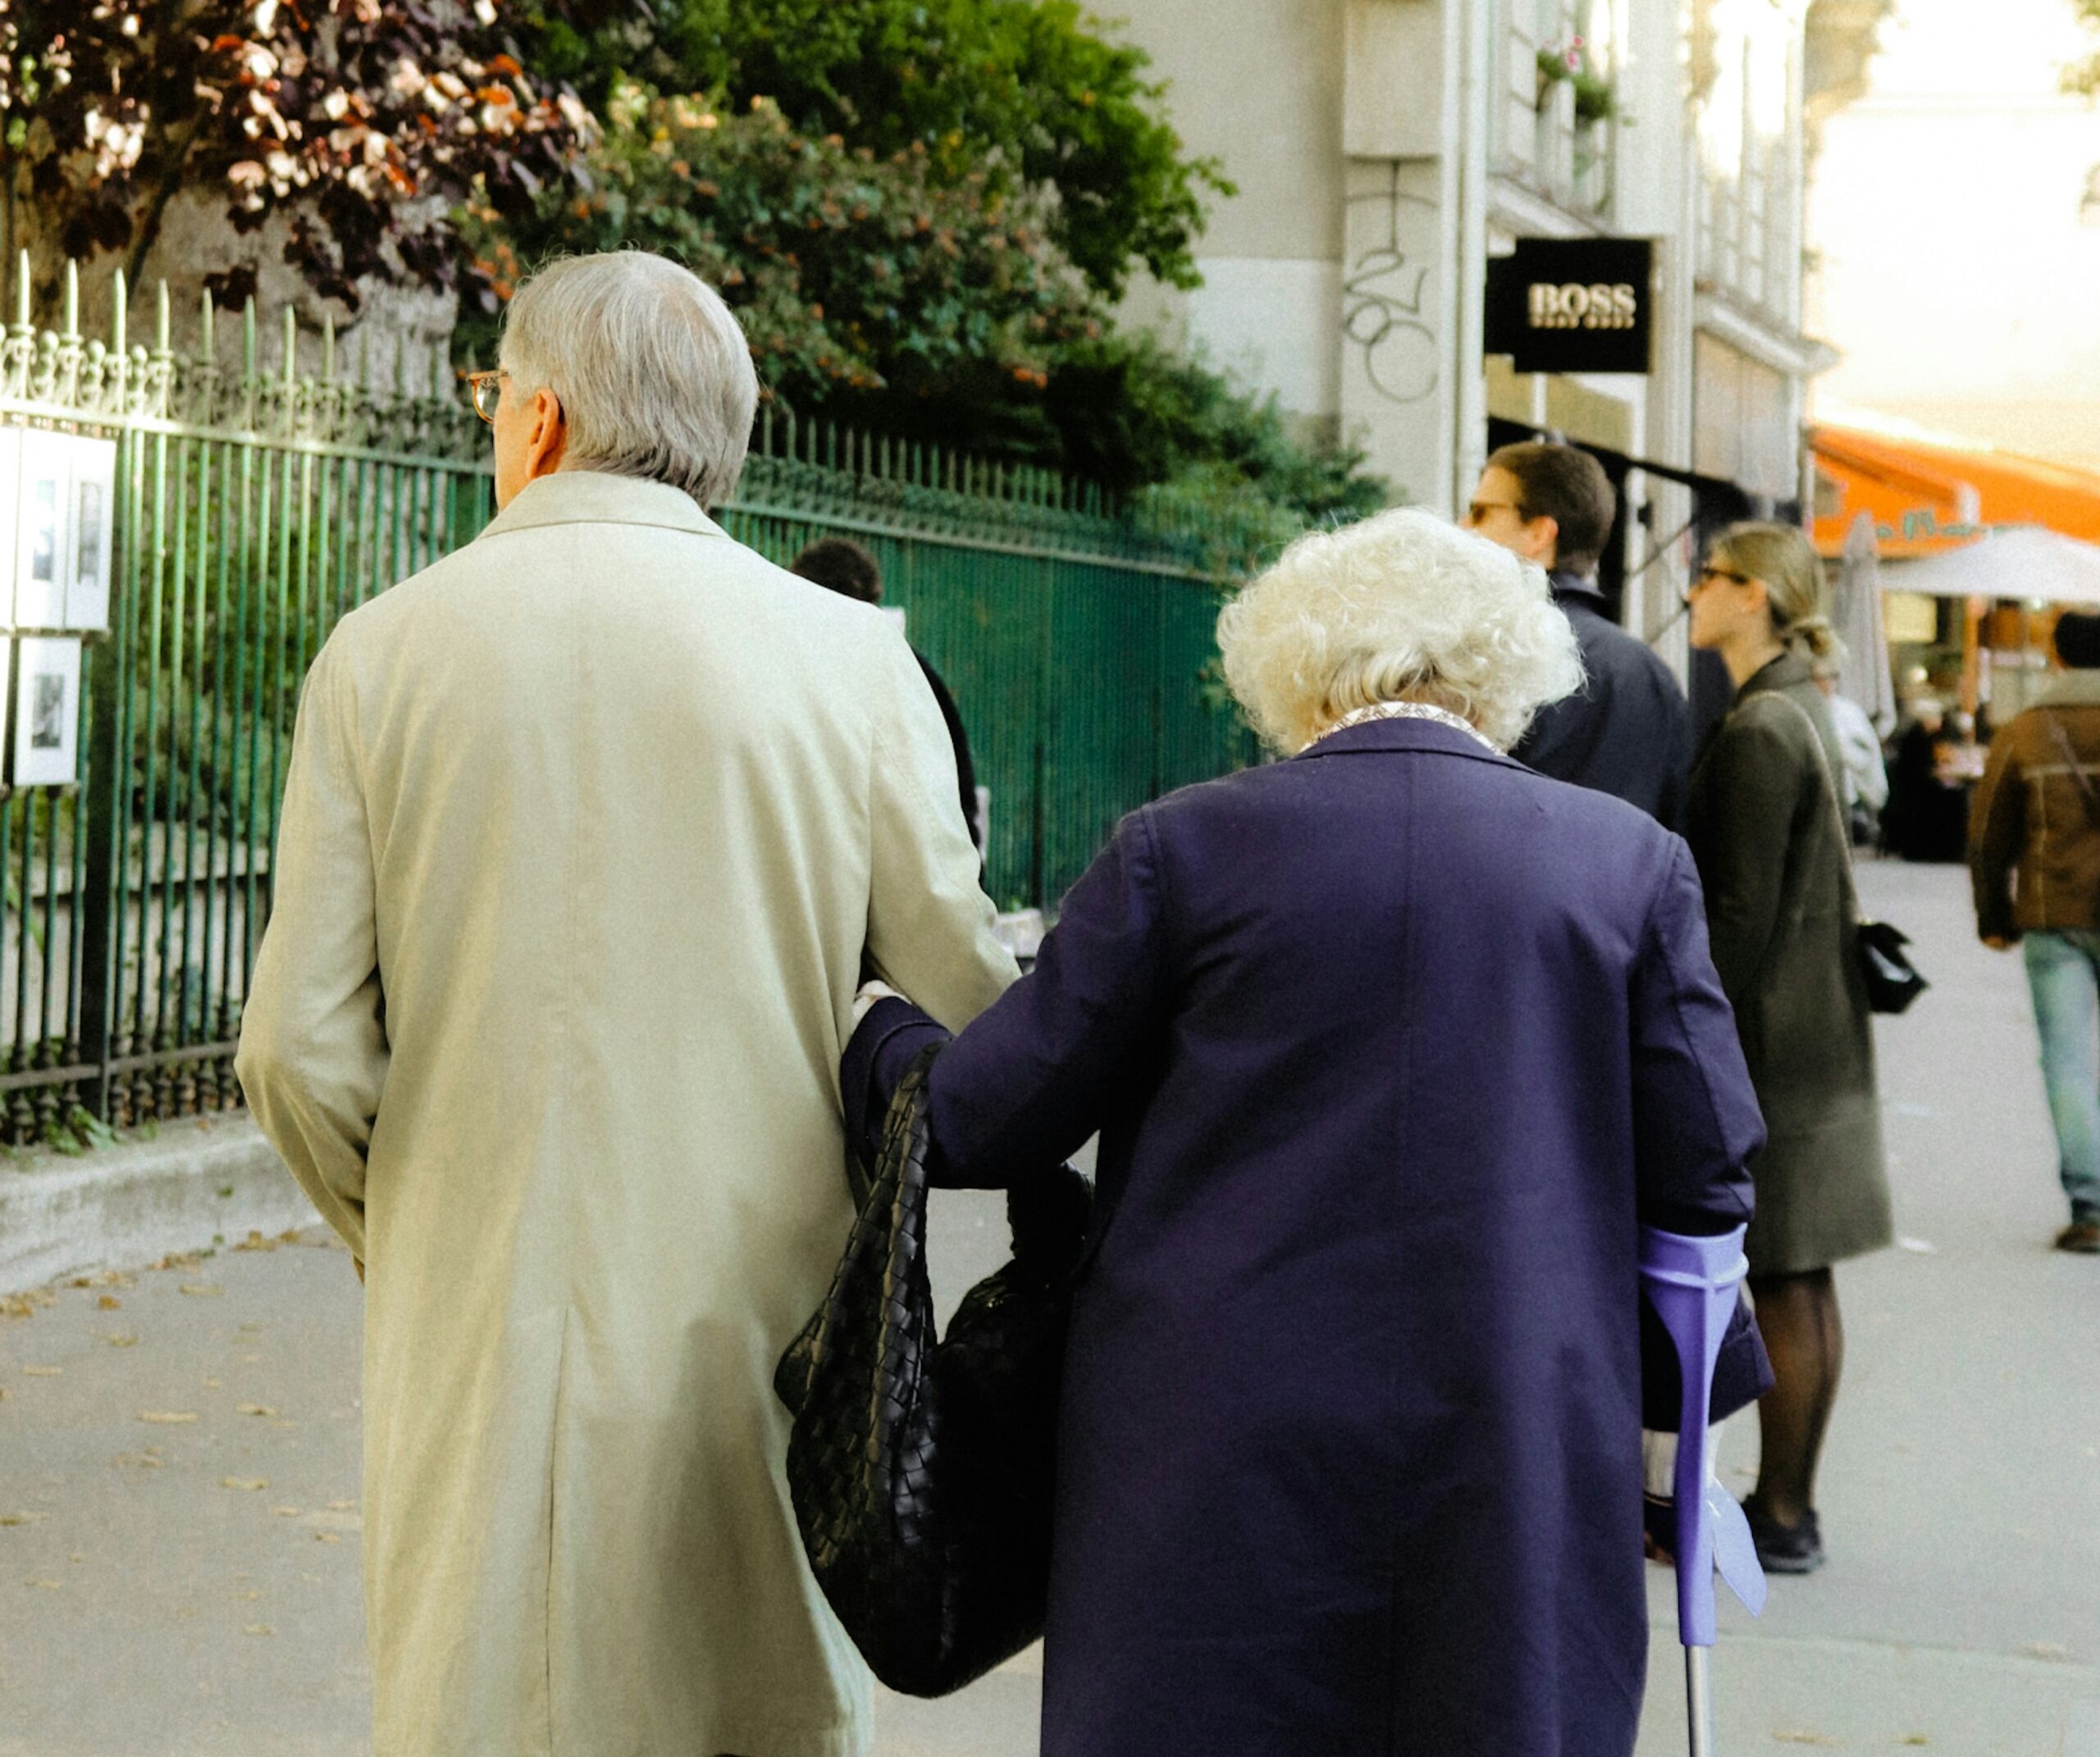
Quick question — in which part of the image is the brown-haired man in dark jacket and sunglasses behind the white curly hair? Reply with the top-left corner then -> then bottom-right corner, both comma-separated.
1463,443 -> 1691,829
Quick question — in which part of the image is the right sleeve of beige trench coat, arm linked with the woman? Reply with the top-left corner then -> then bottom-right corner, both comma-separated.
867,630 -> 1019,1031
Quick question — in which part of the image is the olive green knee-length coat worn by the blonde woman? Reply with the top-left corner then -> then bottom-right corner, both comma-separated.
1684,653 -> 1892,1274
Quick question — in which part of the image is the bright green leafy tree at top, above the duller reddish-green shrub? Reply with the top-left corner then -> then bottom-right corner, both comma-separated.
521,0 -> 1230,300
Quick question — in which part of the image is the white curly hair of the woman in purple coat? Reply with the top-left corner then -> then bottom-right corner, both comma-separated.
1218,508 -> 1583,754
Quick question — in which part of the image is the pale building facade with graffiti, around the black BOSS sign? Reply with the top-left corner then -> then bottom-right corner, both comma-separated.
1119,0 -> 1883,661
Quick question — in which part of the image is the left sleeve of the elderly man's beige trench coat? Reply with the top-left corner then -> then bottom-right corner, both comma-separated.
235,636 -> 389,1272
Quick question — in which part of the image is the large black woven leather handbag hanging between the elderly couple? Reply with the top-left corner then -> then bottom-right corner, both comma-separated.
773,1050 -> 1092,1696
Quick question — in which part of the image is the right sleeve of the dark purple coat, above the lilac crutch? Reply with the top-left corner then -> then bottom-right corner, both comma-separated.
1632,840 -> 1773,1431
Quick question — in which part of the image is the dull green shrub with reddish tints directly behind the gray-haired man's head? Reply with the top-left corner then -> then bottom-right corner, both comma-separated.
458,84 -> 1100,432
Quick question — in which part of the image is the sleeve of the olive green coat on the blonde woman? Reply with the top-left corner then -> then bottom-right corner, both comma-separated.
1692,710 -> 1800,1006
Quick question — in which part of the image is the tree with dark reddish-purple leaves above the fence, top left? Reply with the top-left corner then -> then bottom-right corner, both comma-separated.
0,0 -> 590,311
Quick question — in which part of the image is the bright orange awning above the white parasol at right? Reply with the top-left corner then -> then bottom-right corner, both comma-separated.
1808,427 -> 2100,559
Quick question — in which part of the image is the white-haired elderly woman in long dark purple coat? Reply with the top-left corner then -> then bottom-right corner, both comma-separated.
847,510 -> 1762,1757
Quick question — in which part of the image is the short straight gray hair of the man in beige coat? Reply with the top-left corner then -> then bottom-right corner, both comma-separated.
500,250 -> 758,508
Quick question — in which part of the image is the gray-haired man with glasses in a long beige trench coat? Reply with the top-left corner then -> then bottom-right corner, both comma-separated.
240,254 -> 1014,1757
